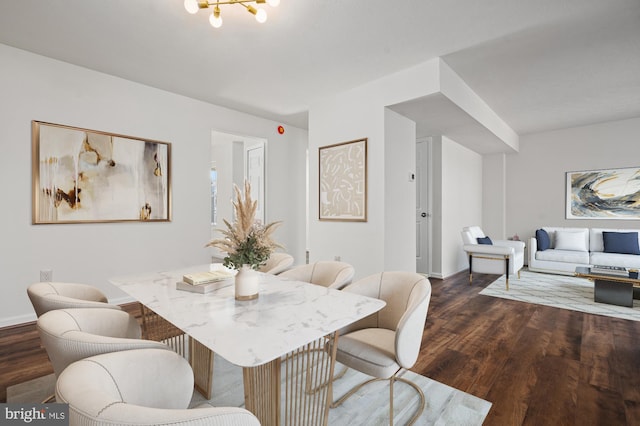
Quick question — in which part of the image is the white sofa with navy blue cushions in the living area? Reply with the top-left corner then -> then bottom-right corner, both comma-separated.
528,226 -> 640,275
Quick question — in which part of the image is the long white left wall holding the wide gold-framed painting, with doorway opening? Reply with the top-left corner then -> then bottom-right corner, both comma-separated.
0,45 -> 307,326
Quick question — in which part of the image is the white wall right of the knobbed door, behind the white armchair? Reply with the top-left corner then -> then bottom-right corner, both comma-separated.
442,136 -> 483,277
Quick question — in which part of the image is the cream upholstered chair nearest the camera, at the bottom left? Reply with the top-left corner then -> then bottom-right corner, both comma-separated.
56,349 -> 260,426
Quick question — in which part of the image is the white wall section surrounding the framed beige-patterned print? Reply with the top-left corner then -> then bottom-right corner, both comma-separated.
309,89 -> 384,279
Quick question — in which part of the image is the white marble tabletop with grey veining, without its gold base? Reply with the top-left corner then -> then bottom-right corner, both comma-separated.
109,264 -> 385,367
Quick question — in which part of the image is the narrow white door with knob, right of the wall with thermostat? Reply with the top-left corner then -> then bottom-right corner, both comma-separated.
416,138 -> 431,274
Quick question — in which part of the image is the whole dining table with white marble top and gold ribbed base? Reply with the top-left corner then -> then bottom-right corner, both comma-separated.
109,264 -> 385,425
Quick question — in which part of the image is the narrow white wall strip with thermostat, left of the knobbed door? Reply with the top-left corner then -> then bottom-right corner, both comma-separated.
384,109 -> 416,272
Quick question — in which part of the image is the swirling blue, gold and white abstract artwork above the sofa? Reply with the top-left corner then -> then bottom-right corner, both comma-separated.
566,167 -> 640,220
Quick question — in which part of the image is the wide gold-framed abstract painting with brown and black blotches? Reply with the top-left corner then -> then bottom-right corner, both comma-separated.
31,121 -> 171,224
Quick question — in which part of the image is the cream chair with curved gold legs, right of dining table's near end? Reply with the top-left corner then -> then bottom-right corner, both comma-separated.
332,271 -> 431,424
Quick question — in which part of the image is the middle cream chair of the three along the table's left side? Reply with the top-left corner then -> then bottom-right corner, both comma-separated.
37,308 -> 171,382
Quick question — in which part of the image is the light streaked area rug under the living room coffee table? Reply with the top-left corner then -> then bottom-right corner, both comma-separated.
480,270 -> 640,321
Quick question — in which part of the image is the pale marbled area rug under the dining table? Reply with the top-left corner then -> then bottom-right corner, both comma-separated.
7,355 -> 491,426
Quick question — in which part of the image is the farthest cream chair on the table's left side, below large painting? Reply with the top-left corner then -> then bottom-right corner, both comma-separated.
27,282 -> 120,317
